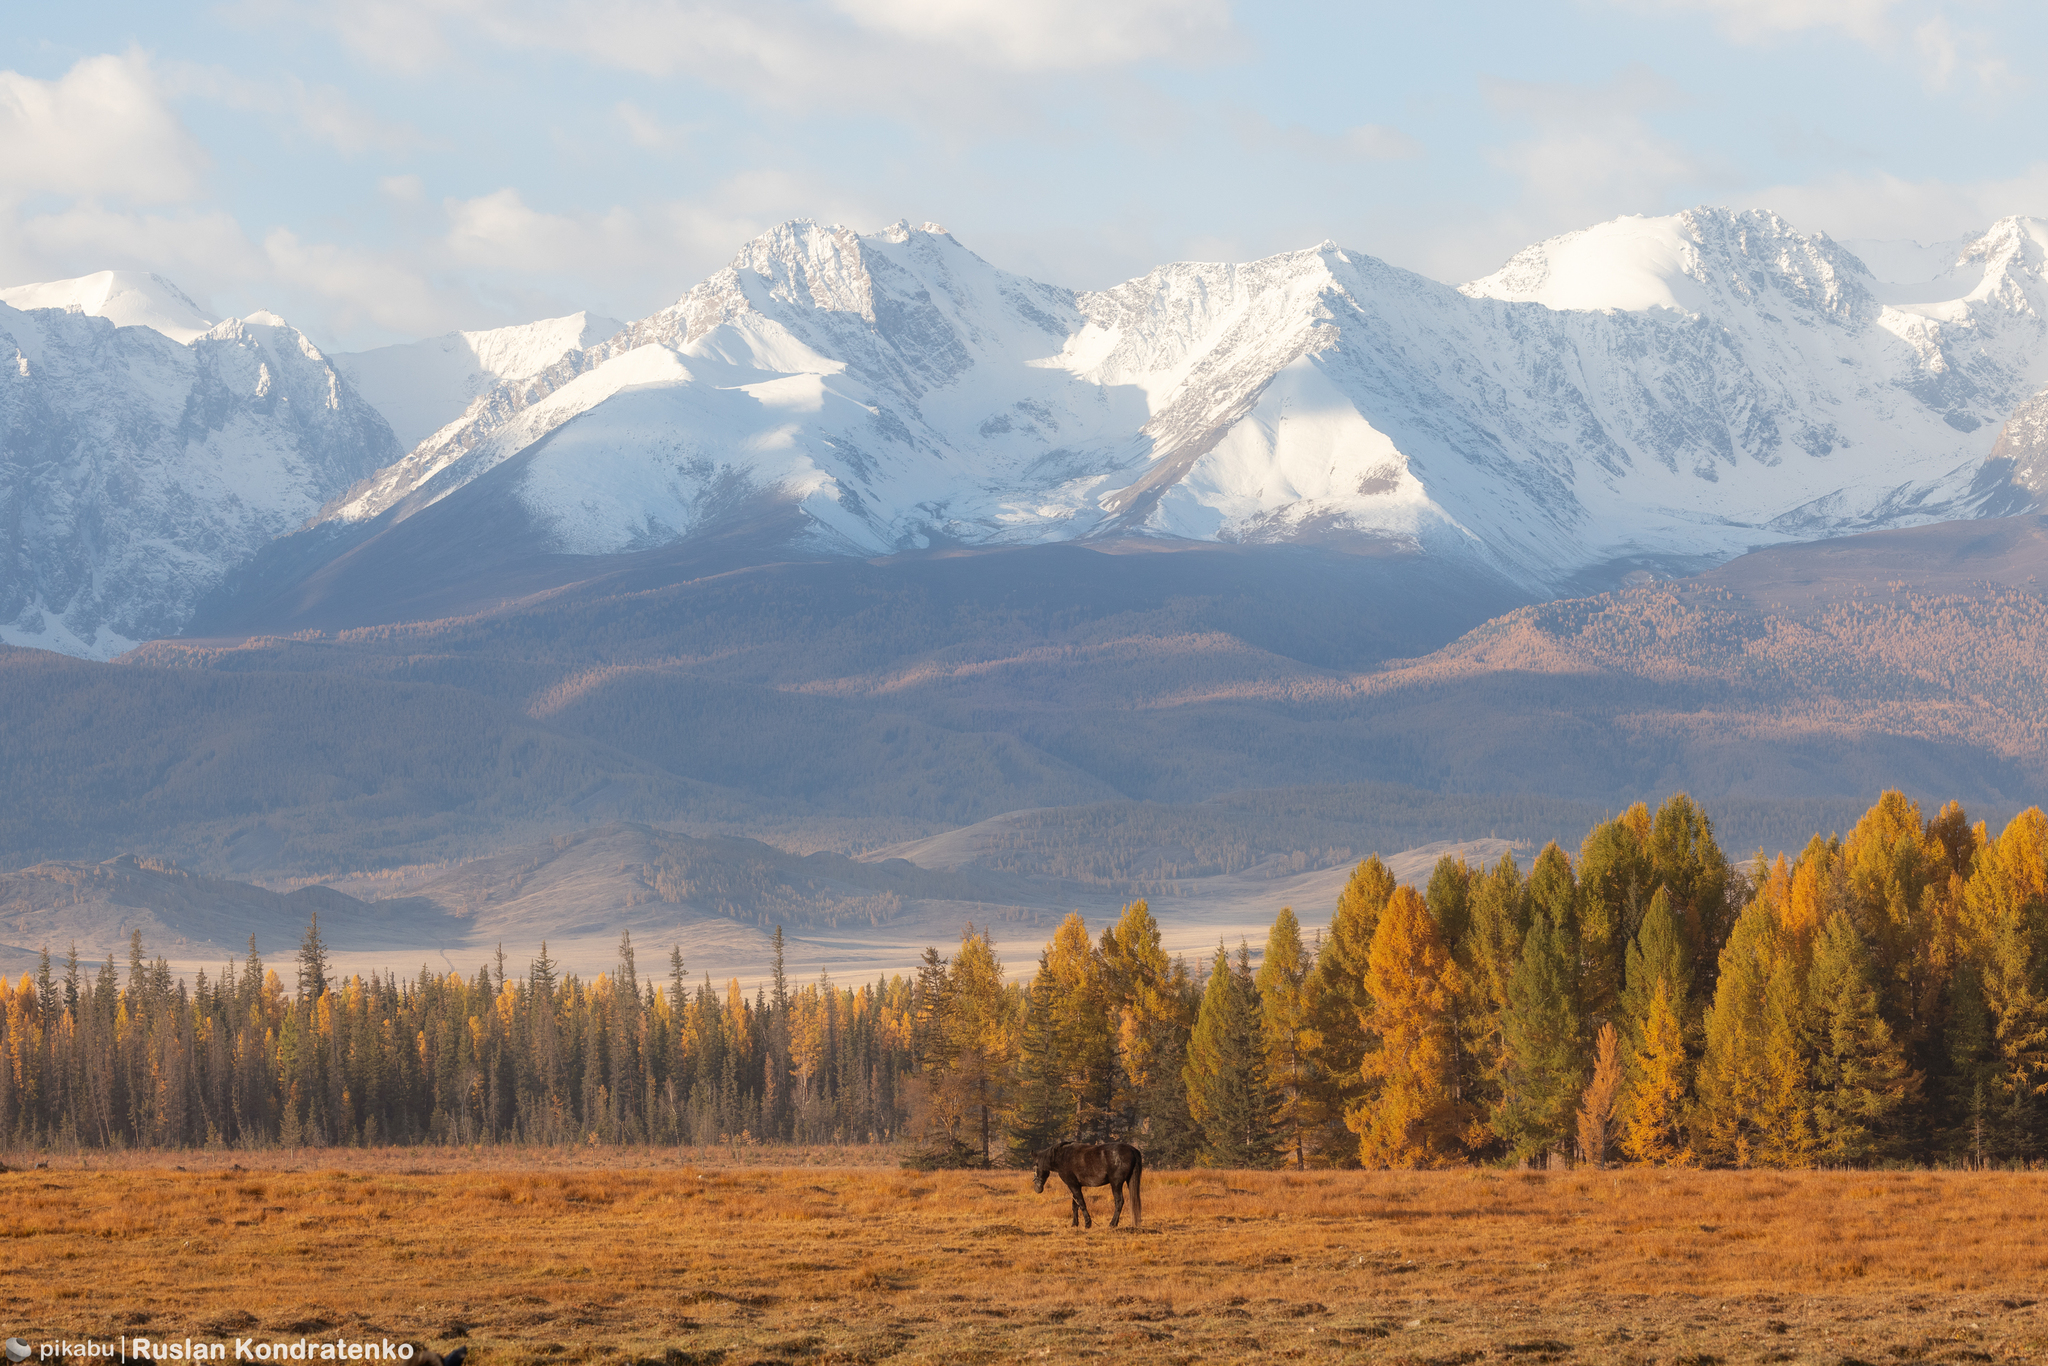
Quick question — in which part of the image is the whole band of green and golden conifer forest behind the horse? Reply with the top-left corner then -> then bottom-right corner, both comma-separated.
0,793 -> 2048,1167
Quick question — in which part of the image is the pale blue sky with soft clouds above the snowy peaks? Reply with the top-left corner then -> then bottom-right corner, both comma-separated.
0,0 -> 2048,350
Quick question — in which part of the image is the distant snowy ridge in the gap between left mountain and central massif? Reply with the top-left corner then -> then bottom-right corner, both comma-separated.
328,313 -> 625,451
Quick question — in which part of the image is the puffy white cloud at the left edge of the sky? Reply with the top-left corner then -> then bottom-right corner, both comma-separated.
0,51 -> 209,205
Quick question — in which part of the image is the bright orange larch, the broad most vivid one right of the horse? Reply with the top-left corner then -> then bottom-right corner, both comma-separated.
1346,887 -> 1466,1167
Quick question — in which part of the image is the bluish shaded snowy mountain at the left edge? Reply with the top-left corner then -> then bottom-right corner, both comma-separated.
0,296 -> 399,657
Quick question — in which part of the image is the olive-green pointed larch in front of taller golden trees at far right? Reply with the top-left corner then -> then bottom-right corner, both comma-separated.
1806,911 -> 1915,1165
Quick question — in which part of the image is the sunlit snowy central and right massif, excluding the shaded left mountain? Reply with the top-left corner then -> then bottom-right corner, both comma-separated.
328,209 -> 2048,590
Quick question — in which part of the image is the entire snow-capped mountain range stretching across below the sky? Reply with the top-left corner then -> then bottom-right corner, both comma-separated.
0,209 -> 2048,655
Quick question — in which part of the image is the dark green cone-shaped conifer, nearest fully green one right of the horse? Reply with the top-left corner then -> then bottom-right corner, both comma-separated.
1182,944 -> 1276,1167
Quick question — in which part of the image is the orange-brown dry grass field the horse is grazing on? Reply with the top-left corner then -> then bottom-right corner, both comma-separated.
0,1149 -> 2048,1366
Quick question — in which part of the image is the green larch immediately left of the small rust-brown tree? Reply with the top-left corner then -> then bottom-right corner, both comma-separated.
1489,911 -> 1587,1161
